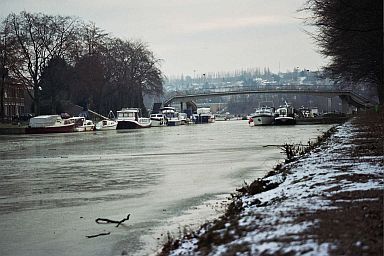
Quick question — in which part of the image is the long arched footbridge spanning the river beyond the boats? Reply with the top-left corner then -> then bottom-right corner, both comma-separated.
163,85 -> 373,113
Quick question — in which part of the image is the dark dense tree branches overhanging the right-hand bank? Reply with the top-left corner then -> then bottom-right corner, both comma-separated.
302,0 -> 384,104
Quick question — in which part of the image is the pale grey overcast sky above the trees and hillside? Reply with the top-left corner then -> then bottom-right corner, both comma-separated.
0,0 -> 325,76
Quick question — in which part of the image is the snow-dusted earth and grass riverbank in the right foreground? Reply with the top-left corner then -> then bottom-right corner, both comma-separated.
161,111 -> 384,255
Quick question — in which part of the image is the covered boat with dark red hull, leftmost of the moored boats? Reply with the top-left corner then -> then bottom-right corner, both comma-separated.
25,115 -> 75,134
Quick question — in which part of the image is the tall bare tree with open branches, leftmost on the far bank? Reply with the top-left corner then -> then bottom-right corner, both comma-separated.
4,12 -> 78,114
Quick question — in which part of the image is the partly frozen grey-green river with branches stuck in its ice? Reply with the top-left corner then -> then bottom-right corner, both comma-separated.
0,121 -> 331,256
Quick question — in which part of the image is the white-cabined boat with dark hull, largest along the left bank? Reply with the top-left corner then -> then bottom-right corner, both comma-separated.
116,108 -> 151,129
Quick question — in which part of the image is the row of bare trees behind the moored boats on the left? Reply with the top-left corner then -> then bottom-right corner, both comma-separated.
0,12 -> 163,115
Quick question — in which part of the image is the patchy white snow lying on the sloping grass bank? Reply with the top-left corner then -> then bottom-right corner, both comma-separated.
171,122 -> 384,255
